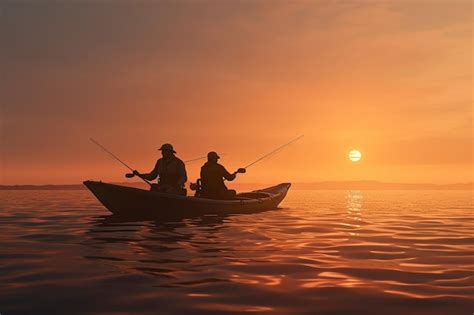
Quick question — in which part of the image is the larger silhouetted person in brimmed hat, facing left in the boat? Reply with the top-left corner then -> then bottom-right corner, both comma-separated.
126,143 -> 188,195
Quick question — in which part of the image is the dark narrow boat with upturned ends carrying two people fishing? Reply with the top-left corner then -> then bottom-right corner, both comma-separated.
84,180 -> 291,217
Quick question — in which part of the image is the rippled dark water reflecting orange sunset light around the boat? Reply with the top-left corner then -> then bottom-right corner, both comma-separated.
0,190 -> 474,315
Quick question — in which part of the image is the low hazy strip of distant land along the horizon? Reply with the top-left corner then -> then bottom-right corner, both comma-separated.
0,180 -> 474,190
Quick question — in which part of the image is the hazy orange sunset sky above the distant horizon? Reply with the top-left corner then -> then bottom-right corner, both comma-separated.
0,0 -> 474,184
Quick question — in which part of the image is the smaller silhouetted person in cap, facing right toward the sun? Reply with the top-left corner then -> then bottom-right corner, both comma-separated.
199,152 -> 245,199
